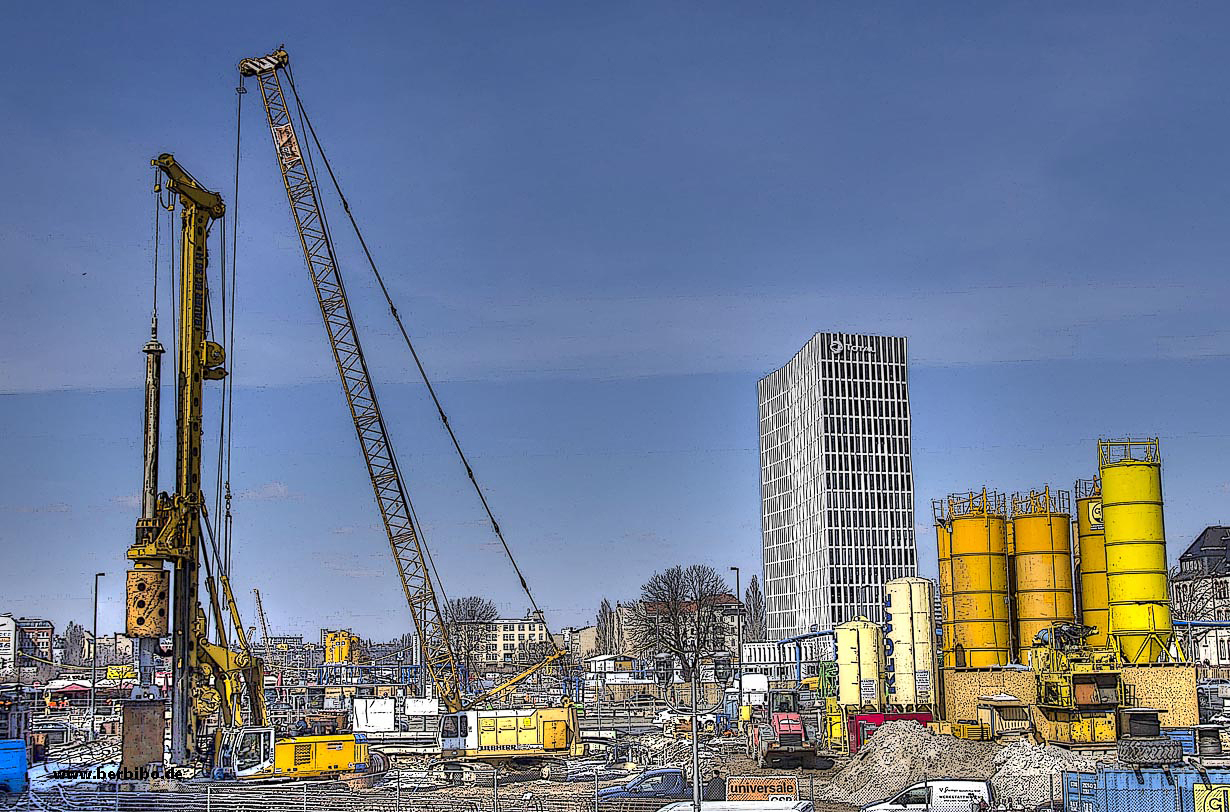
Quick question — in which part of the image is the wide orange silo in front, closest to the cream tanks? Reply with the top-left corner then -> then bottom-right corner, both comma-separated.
946,488 -> 1010,668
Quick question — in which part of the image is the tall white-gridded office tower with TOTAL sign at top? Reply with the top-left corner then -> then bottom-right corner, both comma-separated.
756,332 -> 918,640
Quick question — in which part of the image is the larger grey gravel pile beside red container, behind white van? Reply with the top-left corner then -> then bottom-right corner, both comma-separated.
817,721 -> 999,805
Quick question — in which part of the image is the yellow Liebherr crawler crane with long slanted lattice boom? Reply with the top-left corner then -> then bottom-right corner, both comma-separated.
239,48 -> 583,762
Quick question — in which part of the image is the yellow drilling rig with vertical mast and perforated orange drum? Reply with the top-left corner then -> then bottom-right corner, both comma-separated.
124,153 -> 369,778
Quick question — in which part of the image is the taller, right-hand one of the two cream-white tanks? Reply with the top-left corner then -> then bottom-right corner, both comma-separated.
884,577 -> 937,706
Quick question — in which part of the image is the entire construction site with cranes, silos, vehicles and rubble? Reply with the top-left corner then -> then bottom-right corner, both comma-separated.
0,15 -> 1230,812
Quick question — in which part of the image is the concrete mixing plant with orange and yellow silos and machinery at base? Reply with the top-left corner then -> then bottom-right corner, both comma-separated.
924,439 -> 1199,764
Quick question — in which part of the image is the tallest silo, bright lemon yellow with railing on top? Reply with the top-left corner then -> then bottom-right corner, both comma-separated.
1097,439 -> 1173,663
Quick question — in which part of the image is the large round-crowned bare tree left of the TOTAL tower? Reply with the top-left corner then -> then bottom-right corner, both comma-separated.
627,563 -> 731,679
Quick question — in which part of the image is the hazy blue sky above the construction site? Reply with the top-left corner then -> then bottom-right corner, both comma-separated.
0,2 -> 1230,637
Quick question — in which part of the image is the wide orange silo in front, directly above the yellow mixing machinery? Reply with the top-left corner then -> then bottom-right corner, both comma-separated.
1010,487 -> 1075,663
